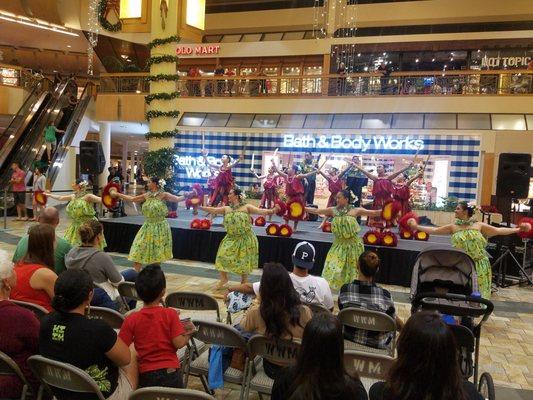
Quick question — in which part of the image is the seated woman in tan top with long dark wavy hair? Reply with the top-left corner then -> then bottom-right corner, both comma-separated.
240,263 -> 313,379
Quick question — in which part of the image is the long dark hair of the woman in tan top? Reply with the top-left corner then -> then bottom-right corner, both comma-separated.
259,263 -> 301,339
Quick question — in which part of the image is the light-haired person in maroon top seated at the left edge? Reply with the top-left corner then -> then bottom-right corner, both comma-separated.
0,250 -> 39,399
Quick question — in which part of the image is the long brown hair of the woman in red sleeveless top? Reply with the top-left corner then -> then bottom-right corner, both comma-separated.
22,224 -> 56,270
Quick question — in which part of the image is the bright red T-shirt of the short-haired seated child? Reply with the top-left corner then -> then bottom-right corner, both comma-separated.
119,306 -> 185,374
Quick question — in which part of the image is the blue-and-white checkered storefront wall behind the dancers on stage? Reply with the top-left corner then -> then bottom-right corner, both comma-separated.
176,131 -> 481,200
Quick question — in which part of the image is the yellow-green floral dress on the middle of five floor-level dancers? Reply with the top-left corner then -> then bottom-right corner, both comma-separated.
215,211 -> 259,274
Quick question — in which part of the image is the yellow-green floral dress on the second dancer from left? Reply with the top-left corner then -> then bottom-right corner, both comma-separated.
128,192 -> 172,264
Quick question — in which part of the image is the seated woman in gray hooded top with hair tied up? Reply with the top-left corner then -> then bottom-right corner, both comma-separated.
65,219 -> 137,310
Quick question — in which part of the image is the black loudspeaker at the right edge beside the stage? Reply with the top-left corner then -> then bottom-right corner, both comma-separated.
496,153 -> 531,199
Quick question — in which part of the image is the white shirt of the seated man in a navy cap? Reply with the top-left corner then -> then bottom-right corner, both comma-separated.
252,272 -> 333,310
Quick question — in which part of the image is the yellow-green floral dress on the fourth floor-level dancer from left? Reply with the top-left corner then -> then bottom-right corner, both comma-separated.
322,207 -> 365,289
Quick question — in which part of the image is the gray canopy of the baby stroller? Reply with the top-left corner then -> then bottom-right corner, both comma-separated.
411,246 -> 478,298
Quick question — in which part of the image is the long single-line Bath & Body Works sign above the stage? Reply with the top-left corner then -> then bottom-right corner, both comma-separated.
282,135 -> 424,152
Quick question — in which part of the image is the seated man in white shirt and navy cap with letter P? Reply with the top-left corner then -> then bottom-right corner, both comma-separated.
229,242 -> 333,310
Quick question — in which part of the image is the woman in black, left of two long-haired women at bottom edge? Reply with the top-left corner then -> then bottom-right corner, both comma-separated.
271,313 -> 368,400
